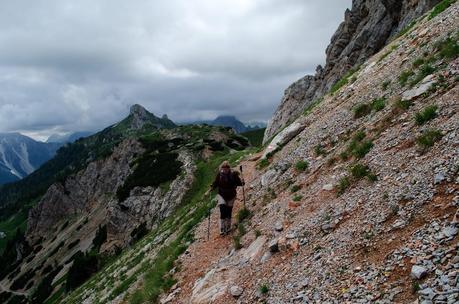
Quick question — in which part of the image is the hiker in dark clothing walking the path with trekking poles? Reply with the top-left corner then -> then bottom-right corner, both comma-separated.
211,161 -> 244,235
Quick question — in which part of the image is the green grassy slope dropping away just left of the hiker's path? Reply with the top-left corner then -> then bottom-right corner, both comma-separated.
55,150 -> 252,303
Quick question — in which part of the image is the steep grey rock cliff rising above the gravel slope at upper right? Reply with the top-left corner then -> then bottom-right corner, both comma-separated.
264,0 -> 440,142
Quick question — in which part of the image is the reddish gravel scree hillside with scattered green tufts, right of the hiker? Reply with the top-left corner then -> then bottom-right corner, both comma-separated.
162,3 -> 459,303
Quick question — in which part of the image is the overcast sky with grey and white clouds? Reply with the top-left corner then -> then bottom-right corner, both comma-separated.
0,0 -> 351,139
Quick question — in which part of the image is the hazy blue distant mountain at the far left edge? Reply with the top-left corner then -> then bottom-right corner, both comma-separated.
0,133 -> 61,184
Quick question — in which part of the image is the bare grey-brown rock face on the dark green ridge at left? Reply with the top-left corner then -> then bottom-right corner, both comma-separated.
27,140 -> 143,238
